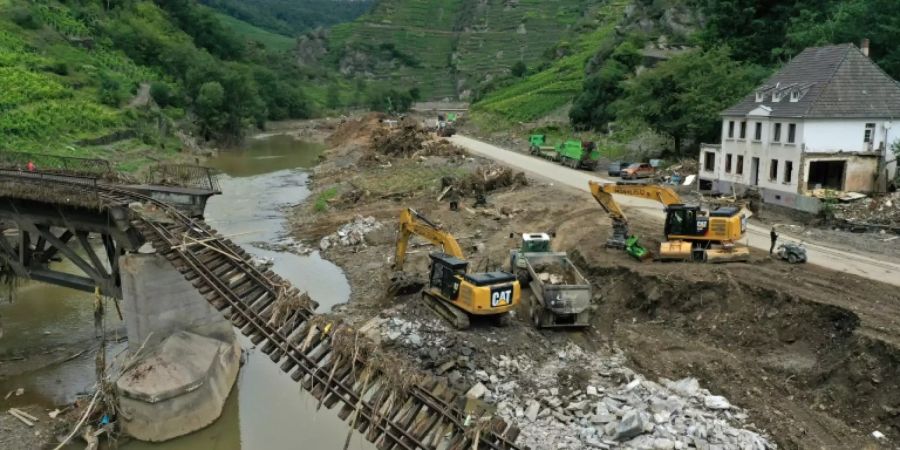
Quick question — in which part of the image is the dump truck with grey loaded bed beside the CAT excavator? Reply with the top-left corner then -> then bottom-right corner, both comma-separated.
510,233 -> 593,328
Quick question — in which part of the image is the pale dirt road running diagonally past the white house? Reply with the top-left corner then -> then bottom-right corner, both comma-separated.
450,135 -> 900,286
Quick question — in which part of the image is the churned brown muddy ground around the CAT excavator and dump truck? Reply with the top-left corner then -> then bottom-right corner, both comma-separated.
292,118 -> 900,449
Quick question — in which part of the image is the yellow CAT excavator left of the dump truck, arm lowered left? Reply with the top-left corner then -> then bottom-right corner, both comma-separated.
394,208 -> 521,330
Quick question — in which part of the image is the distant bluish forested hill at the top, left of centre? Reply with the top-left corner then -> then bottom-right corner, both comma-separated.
201,0 -> 374,36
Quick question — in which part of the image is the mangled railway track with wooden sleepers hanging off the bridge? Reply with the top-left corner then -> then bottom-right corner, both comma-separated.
3,173 -> 523,450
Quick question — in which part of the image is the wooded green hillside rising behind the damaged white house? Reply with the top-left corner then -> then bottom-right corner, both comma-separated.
474,0 -> 900,153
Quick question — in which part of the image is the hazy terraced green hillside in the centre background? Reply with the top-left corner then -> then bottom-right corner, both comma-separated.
331,0 -> 590,98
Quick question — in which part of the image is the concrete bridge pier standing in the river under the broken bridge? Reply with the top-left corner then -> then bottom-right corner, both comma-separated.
117,252 -> 241,442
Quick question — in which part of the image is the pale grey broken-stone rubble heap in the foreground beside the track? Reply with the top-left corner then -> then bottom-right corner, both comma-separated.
376,317 -> 776,450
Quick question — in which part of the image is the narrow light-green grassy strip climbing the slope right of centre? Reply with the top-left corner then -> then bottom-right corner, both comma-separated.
472,0 -> 630,129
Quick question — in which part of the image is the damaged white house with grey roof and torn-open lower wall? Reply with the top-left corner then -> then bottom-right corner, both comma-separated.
699,43 -> 900,212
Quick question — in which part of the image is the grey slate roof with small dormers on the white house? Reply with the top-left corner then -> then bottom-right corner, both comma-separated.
722,44 -> 900,118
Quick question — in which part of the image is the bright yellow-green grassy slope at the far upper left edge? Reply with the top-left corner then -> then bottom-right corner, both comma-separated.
0,2 -> 139,154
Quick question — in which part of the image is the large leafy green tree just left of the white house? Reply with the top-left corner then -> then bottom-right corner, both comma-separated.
614,47 -> 767,155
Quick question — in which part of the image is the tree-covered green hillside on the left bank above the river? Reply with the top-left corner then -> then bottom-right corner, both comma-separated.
0,0 -> 324,167
